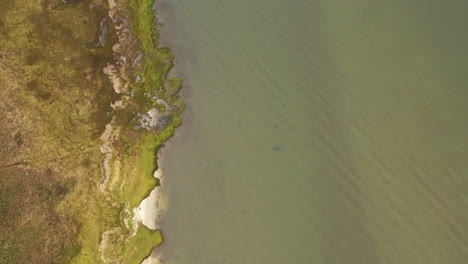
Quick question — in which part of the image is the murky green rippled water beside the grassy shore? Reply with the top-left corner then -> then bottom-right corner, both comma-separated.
152,0 -> 468,264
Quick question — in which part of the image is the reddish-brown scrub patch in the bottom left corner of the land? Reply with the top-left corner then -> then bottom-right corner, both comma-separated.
0,162 -> 73,263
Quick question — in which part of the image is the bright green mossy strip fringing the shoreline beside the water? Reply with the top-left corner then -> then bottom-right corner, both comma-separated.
68,0 -> 183,263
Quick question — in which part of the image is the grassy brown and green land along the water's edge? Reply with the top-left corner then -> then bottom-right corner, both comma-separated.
0,0 -> 184,263
